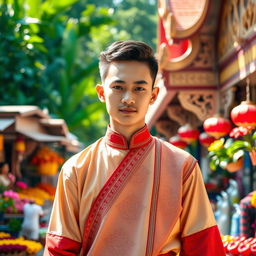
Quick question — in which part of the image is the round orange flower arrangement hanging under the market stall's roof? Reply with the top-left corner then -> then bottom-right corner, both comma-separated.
31,147 -> 64,175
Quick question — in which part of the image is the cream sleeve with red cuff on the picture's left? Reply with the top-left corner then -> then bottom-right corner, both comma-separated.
44,159 -> 81,256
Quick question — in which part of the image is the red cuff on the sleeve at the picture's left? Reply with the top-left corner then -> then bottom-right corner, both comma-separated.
44,233 -> 81,256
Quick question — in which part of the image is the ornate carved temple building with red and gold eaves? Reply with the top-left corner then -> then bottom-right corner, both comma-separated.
147,0 -> 256,140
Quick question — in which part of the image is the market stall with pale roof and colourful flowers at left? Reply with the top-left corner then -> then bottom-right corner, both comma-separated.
0,106 -> 81,251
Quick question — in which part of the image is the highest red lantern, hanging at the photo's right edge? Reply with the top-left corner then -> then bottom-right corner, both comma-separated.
231,101 -> 256,127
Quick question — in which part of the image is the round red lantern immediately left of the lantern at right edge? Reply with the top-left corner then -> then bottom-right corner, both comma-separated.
203,116 -> 232,139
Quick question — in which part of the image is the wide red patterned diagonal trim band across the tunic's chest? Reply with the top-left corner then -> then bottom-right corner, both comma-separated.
82,143 -> 153,255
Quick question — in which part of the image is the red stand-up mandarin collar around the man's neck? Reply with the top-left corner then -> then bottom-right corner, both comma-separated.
105,125 -> 153,150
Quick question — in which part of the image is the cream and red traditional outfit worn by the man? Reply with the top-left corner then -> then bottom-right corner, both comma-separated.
44,126 -> 225,256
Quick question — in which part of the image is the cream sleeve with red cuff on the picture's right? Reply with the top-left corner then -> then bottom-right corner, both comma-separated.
180,165 -> 225,256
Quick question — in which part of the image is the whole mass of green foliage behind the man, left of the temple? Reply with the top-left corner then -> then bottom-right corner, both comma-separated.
0,0 -> 157,144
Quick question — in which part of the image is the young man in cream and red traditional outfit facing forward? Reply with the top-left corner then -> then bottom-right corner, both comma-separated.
44,41 -> 225,256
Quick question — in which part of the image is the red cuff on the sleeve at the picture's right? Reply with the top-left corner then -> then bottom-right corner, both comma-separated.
180,226 -> 226,256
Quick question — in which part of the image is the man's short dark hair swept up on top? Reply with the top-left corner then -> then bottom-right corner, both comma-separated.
99,40 -> 158,85
